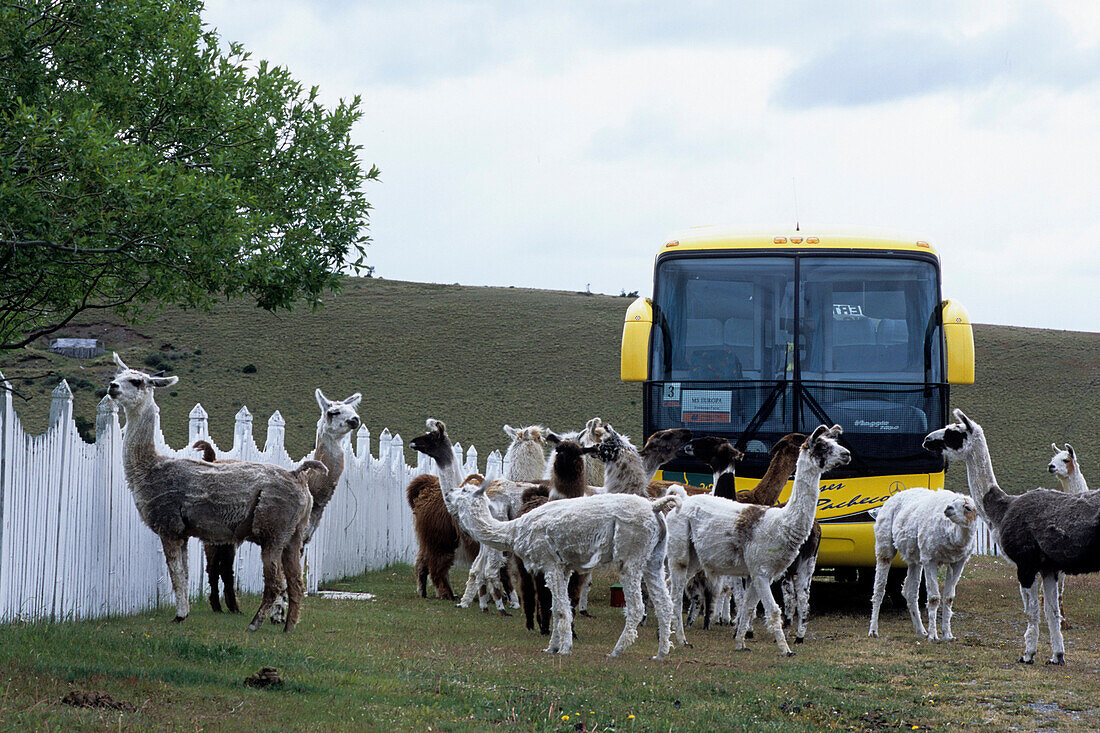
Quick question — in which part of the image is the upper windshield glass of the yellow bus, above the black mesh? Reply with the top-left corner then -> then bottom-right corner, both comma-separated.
651,255 -> 942,384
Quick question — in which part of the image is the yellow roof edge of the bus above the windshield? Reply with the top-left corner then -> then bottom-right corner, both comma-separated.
658,226 -> 936,256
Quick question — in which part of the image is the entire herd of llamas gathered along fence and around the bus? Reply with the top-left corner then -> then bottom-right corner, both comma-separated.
108,354 -> 1100,665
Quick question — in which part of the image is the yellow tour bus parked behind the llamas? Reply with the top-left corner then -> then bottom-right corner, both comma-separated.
620,227 -> 974,580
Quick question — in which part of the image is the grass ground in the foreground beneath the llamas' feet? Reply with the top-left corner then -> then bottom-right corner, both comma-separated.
0,558 -> 1100,732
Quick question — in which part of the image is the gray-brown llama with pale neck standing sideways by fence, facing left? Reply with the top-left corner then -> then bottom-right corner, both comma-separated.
107,353 -> 326,632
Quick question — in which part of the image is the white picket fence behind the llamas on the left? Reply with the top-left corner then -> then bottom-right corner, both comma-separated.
0,374 -> 504,622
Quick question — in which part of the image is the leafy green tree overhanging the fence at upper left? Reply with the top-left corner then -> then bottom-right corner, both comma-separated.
0,0 -> 378,349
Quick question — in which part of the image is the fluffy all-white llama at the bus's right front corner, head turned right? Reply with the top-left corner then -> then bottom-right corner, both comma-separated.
868,488 -> 978,642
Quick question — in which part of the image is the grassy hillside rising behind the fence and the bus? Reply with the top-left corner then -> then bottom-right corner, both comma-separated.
0,278 -> 1100,491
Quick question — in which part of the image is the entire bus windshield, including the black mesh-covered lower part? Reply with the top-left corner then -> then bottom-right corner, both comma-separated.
646,252 -> 947,475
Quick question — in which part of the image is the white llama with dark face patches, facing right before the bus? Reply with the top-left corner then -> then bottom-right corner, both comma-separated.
669,425 -> 851,656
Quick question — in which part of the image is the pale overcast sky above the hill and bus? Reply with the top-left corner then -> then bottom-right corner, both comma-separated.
204,0 -> 1100,331
